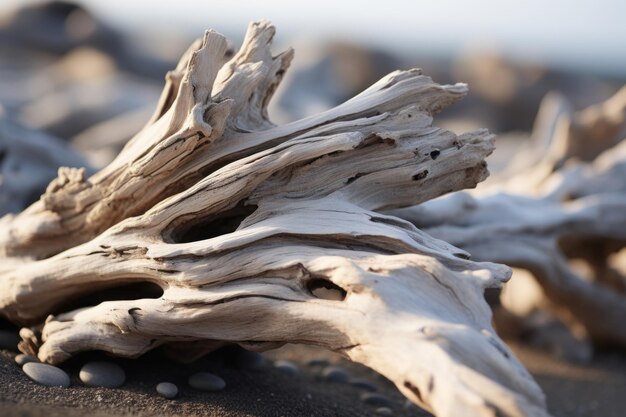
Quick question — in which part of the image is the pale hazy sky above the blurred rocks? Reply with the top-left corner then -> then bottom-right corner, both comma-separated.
0,0 -> 626,74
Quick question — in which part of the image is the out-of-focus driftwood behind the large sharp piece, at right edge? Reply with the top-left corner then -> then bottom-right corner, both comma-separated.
393,87 -> 626,356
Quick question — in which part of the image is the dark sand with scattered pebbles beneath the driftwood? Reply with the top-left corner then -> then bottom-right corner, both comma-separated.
0,340 -> 626,417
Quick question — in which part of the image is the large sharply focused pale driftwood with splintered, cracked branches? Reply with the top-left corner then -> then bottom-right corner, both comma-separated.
0,22 -> 547,417
